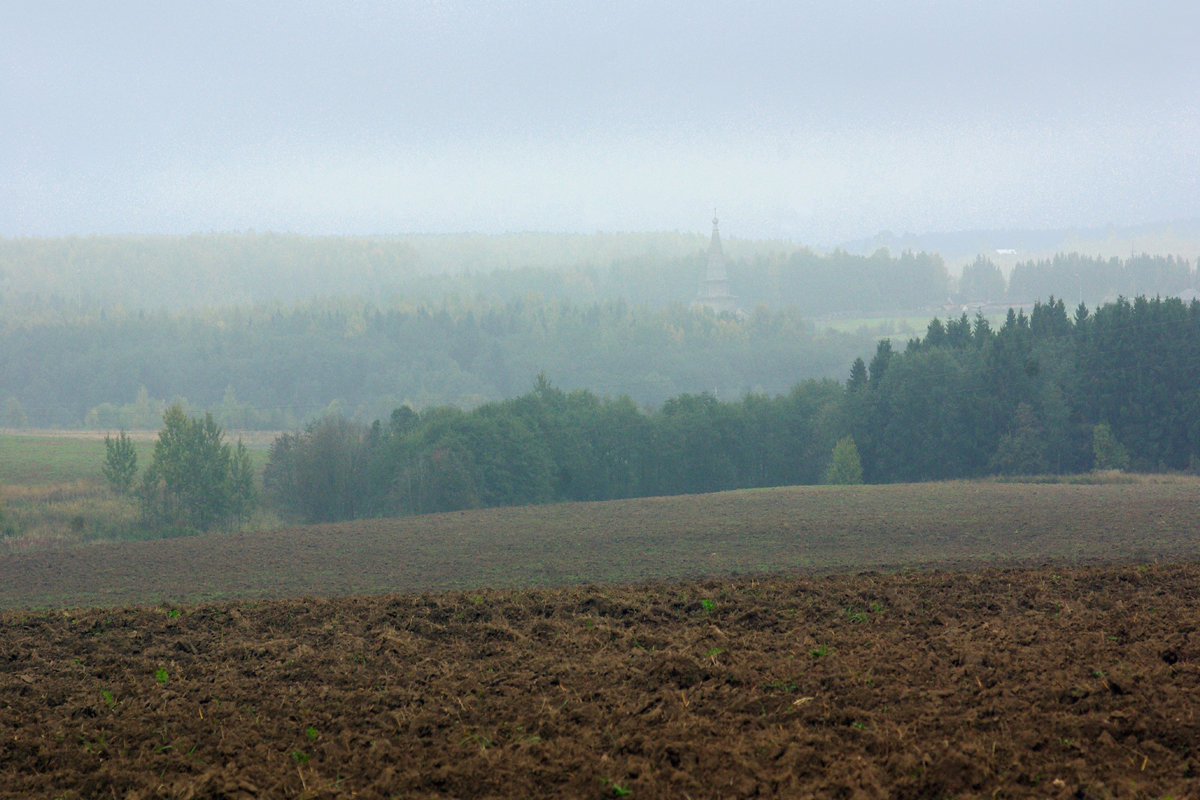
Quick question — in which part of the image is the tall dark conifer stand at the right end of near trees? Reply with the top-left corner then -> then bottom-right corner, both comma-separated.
846,296 -> 1200,481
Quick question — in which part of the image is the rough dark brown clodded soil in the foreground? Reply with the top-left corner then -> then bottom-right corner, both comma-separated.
0,564 -> 1200,799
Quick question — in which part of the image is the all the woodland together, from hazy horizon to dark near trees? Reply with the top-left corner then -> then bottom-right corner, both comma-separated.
7,227 -> 1200,531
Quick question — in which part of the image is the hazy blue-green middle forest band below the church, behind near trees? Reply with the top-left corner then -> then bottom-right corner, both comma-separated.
0,295 -> 877,431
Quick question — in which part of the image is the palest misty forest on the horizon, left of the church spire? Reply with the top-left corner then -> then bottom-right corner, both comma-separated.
0,233 -> 748,314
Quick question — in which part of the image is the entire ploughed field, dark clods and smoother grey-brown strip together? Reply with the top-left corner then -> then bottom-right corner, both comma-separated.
0,483 -> 1200,800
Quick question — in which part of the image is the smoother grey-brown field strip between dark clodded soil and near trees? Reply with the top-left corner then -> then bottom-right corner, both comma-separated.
0,476 -> 1200,607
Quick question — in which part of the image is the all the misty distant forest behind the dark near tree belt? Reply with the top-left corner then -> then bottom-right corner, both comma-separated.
0,233 -> 1196,431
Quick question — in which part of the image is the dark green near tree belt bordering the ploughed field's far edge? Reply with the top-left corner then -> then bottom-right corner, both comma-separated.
264,296 -> 1200,522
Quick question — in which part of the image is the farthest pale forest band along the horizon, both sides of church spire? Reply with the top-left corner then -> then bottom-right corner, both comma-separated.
7,233 -> 1196,321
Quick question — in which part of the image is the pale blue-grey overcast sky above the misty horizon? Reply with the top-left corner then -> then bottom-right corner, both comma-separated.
0,0 -> 1200,247
